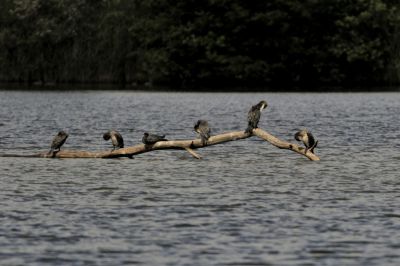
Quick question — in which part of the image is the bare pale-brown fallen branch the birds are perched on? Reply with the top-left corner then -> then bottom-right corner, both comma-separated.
0,128 -> 319,161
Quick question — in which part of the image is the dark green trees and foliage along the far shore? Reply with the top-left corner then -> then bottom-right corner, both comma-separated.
0,0 -> 400,87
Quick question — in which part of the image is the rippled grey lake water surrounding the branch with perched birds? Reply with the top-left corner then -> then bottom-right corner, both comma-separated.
0,91 -> 400,265
